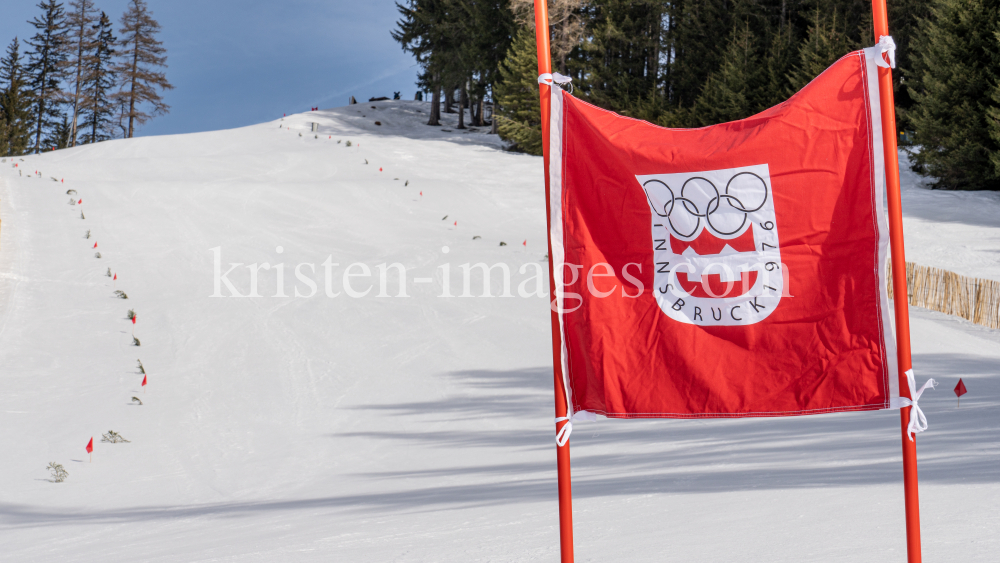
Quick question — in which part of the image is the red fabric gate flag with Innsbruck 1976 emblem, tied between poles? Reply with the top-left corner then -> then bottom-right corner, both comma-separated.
549,47 -> 899,418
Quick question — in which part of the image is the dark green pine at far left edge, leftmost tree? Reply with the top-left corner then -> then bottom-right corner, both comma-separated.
0,37 -> 32,156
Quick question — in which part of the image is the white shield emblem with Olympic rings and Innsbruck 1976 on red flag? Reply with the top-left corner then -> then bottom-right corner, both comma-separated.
636,164 -> 785,326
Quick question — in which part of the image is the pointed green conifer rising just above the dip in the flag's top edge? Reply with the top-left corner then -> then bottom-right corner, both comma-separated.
693,21 -> 769,126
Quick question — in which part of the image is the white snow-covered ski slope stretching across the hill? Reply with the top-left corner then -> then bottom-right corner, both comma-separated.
0,102 -> 1000,562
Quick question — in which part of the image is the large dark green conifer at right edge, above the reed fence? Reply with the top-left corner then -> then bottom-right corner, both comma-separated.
908,0 -> 1000,190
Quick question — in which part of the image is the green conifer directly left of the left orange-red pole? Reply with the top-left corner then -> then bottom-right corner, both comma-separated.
495,26 -> 542,155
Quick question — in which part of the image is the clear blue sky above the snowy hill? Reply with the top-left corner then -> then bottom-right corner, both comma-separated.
0,0 -> 418,135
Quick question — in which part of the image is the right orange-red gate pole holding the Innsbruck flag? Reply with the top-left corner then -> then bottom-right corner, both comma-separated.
872,0 -> 921,563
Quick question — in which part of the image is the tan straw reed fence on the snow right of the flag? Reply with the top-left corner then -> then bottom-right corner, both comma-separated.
886,262 -> 1000,328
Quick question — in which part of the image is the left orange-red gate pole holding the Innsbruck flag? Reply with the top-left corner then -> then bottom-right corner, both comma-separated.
535,0 -> 573,563
